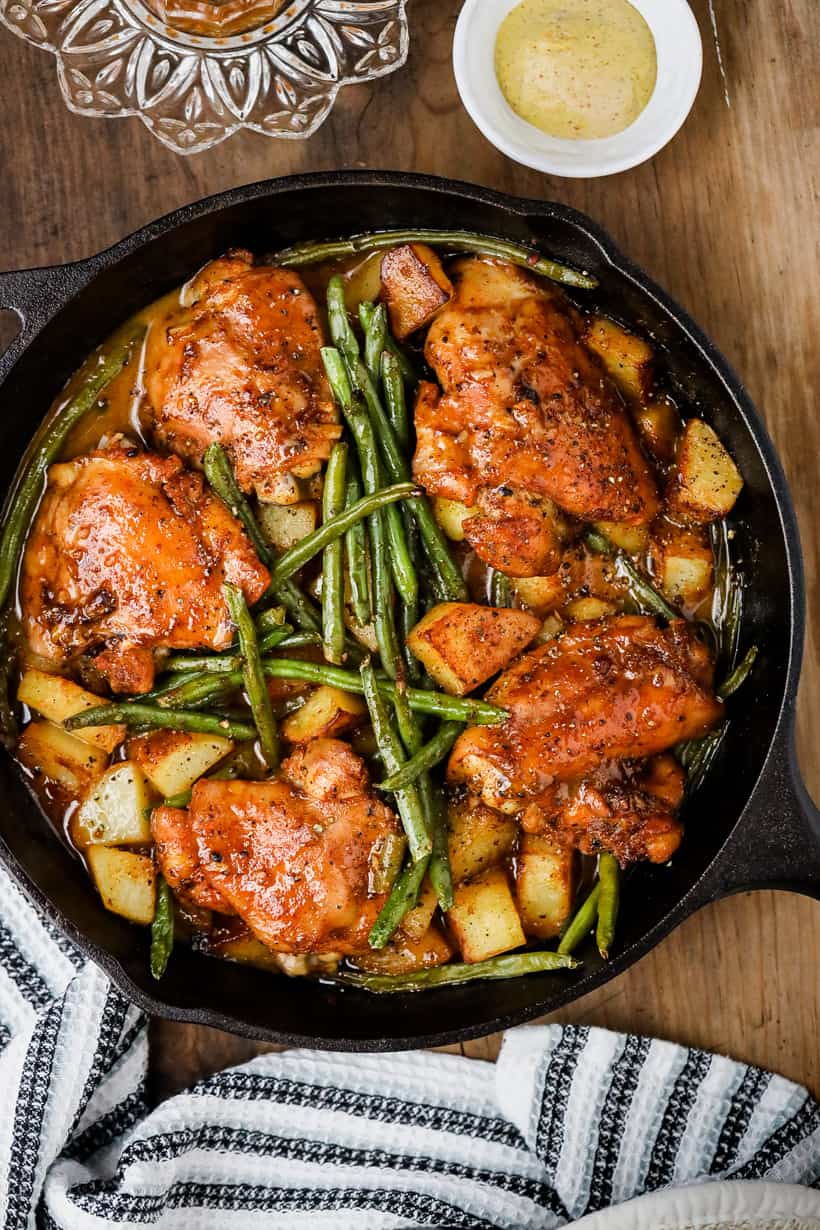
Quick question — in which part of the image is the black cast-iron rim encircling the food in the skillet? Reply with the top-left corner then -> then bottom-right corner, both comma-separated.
0,170 -> 805,1052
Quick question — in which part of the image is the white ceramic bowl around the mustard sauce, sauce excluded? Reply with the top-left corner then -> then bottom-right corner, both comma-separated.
452,0 -> 703,178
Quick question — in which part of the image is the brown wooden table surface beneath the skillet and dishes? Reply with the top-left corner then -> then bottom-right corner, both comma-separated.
0,0 -> 820,1096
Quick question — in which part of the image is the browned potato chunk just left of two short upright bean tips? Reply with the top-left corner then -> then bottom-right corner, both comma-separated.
515,833 -> 575,940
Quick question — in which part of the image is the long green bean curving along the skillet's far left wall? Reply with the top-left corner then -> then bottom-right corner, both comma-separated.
0,325 -> 145,606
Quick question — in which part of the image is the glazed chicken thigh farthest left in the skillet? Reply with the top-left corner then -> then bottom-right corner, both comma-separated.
21,440 -> 270,692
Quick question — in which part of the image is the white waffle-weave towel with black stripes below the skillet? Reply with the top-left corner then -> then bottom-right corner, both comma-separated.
0,871 -> 820,1230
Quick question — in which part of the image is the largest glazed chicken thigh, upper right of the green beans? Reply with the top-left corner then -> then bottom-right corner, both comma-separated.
413,257 -> 659,577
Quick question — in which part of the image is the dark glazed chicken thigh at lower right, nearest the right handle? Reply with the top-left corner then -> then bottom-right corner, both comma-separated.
447,615 -> 723,862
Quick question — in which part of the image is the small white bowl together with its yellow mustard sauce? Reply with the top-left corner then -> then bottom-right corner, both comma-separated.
452,0 -> 703,177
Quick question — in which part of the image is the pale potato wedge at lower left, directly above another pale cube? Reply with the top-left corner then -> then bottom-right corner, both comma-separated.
71,760 -> 151,850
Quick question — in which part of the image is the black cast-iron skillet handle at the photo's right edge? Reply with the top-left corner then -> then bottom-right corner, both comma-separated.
696,715 -> 820,904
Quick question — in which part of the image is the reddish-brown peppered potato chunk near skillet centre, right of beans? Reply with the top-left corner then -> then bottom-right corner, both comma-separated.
407,603 -> 540,696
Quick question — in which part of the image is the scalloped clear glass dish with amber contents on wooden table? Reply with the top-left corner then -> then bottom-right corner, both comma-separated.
0,0 -> 408,154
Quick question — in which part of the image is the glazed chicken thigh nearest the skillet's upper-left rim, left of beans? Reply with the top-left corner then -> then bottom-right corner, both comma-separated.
145,252 -> 341,504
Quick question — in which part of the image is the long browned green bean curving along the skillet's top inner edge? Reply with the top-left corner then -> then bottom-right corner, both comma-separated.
275,228 -> 597,290
